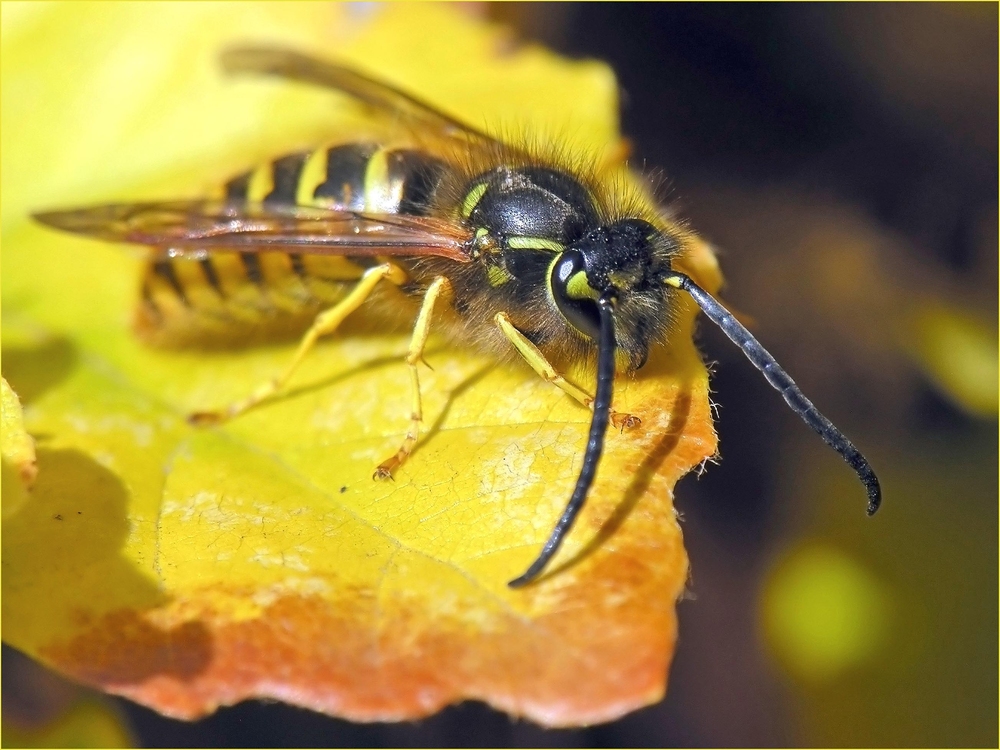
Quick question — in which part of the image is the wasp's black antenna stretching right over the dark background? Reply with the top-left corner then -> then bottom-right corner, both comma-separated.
664,271 -> 882,516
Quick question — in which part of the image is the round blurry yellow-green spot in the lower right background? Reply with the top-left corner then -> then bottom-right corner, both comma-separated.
761,545 -> 887,682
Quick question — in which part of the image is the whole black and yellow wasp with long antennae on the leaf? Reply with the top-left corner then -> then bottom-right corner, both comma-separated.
35,48 -> 881,588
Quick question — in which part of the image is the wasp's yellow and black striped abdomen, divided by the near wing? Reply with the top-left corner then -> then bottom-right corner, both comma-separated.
136,142 -> 456,346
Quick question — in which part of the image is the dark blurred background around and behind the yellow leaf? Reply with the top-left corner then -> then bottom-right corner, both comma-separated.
3,3 -> 998,747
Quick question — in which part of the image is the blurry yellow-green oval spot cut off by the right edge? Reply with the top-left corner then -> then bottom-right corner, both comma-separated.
911,305 -> 1000,424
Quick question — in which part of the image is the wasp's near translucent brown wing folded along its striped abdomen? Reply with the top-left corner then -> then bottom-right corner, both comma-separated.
35,200 -> 472,262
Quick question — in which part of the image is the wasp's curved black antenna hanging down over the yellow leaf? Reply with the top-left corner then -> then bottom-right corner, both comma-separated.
507,297 -> 616,589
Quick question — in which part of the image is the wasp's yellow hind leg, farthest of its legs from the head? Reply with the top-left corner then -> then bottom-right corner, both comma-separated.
188,263 -> 407,425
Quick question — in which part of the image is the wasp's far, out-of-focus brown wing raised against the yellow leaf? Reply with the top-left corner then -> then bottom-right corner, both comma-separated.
222,47 -> 499,148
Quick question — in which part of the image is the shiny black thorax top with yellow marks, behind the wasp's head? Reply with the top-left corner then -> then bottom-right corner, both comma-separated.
462,167 -> 598,252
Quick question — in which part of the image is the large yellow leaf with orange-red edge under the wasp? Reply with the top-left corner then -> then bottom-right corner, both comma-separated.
2,4 -> 719,726
